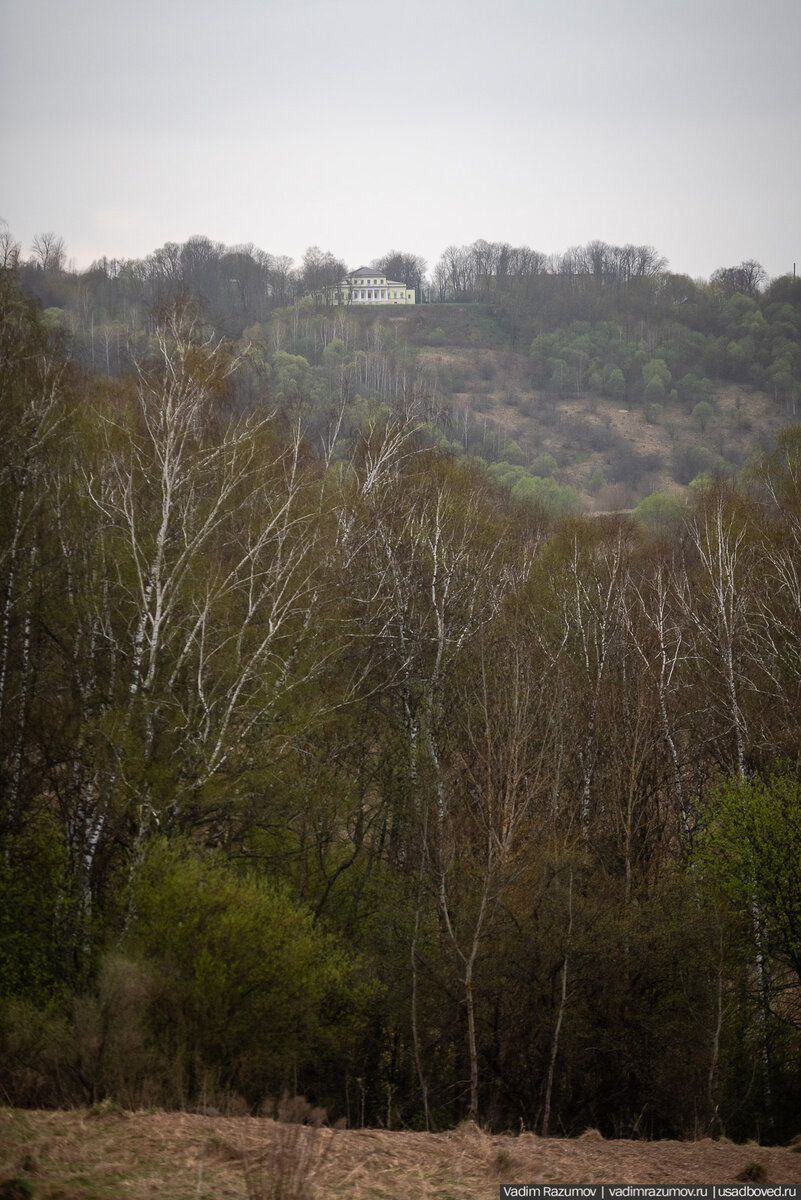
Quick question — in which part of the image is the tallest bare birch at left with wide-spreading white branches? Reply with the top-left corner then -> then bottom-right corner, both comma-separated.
45,313 -> 338,945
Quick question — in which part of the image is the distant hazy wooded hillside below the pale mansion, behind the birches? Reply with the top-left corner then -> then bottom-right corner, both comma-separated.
12,234 -> 801,515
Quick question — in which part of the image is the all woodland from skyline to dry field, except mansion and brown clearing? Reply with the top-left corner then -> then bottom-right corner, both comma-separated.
0,235 -> 801,1139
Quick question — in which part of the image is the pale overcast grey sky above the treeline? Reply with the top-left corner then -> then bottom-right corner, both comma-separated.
0,0 -> 801,277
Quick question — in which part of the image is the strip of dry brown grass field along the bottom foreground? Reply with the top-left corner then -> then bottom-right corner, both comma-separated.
0,1106 -> 801,1200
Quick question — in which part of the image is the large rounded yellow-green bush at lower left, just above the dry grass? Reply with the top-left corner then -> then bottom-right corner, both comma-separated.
126,844 -> 374,1102
